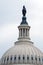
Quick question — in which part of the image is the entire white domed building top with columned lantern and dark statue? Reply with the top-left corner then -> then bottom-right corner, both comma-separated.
1,6 -> 43,65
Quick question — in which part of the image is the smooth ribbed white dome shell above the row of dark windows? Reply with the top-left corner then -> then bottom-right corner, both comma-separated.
3,44 -> 43,57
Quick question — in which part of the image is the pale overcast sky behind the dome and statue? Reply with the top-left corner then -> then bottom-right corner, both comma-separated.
0,0 -> 43,58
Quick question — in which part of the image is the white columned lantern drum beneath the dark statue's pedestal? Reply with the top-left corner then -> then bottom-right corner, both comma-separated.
18,25 -> 30,40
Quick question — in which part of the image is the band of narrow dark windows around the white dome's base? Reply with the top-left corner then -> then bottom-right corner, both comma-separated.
2,55 -> 43,65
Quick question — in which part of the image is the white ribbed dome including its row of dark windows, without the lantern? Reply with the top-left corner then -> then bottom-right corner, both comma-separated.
2,43 -> 43,64
